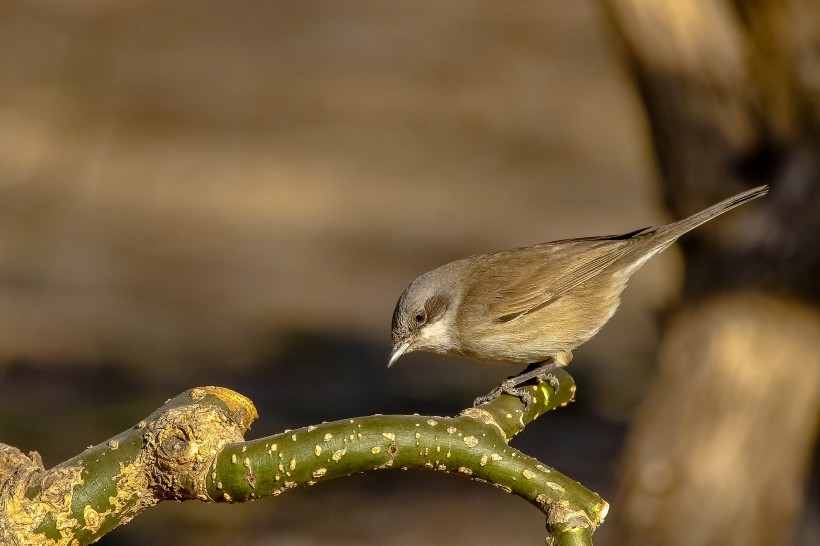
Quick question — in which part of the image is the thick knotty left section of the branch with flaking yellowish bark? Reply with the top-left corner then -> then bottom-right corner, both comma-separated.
0,387 -> 256,545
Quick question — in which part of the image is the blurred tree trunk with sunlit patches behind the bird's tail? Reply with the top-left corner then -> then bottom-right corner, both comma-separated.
601,0 -> 820,546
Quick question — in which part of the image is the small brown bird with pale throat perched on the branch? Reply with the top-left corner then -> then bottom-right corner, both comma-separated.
388,186 -> 769,404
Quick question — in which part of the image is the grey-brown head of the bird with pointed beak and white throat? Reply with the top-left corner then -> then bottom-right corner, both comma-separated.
387,272 -> 455,367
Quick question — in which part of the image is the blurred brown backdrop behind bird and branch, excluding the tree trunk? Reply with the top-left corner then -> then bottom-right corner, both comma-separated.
0,0 -> 818,545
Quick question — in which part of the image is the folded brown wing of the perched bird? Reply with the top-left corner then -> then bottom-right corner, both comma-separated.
486,228 -> 649,322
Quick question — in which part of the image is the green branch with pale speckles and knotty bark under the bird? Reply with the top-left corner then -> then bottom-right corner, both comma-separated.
0,370 -> 608,545
